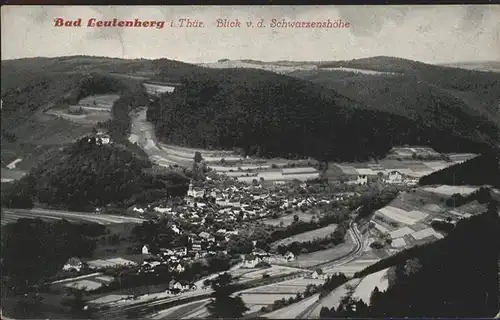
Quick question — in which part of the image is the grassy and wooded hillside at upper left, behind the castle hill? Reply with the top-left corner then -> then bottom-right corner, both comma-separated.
1,56 -> 199,170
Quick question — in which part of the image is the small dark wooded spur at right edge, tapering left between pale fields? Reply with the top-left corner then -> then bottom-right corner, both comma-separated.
419,156 -> 500,188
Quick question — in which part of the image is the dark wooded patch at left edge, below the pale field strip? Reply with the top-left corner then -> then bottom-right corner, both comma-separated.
1,219 -> 106,290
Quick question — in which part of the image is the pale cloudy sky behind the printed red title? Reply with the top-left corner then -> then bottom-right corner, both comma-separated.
1,5 -> 500,63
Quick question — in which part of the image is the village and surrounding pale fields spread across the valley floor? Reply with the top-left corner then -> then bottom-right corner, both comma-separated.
38,131 -> 486,319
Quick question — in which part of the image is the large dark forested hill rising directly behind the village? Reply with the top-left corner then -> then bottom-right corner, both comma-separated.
148,69 -> 500,161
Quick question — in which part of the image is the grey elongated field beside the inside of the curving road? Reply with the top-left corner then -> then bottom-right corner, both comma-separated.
288,236 -> 355,268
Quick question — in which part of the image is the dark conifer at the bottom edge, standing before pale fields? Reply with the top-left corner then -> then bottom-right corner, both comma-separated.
207,272 -> 249,319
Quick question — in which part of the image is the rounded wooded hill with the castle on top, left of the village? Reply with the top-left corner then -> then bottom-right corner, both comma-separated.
2,137 -> 189,211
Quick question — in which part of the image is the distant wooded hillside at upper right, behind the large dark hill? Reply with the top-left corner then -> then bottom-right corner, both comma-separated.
290,57 -> 500,127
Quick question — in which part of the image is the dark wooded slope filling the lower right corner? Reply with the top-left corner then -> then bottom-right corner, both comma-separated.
323,201 -> 500,318
